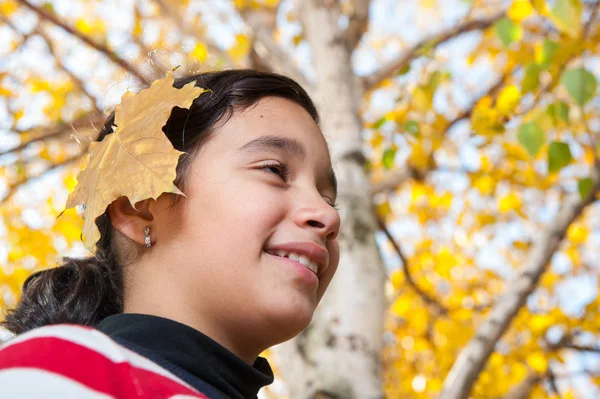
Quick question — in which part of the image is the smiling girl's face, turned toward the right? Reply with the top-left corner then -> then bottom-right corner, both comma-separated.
153,97 -> 340,356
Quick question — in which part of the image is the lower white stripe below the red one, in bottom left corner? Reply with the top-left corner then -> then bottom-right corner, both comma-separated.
0,368 -> 114,399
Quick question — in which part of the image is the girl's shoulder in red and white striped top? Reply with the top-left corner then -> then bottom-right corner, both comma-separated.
0,324 -> 207,398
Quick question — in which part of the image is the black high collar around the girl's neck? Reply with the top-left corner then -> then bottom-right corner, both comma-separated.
96,313 -> 273,399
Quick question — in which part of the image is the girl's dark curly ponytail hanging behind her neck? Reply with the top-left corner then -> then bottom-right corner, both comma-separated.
0,214 -> 123,334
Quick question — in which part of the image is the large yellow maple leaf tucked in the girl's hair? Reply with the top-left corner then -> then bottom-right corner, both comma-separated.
66,72 -> 205,251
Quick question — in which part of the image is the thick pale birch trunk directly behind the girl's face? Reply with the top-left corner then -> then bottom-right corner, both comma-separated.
274,0 -> 385,399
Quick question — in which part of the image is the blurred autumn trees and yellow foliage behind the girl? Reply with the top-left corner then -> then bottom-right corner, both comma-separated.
0,0 -> 600,399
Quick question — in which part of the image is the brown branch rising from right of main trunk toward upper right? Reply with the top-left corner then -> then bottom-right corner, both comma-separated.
362,12 -> 505,91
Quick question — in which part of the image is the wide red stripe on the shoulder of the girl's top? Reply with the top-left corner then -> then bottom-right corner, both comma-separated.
0,337 -> 209,399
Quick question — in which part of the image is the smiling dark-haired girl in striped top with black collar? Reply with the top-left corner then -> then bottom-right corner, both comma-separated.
0,70 -> 340,398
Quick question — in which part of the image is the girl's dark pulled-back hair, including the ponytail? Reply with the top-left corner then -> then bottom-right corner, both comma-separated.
1,69 -> 319,334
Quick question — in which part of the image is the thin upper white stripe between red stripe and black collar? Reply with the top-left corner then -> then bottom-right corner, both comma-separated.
0,324 -> 196,391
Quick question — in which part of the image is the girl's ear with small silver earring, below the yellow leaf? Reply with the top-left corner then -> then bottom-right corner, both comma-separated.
108,197 -> 154,244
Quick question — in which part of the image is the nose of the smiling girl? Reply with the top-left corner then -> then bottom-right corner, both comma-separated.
294,192 -> 340,242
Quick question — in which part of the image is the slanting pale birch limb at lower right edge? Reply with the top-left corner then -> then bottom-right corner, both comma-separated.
439,165 -> 600,399
